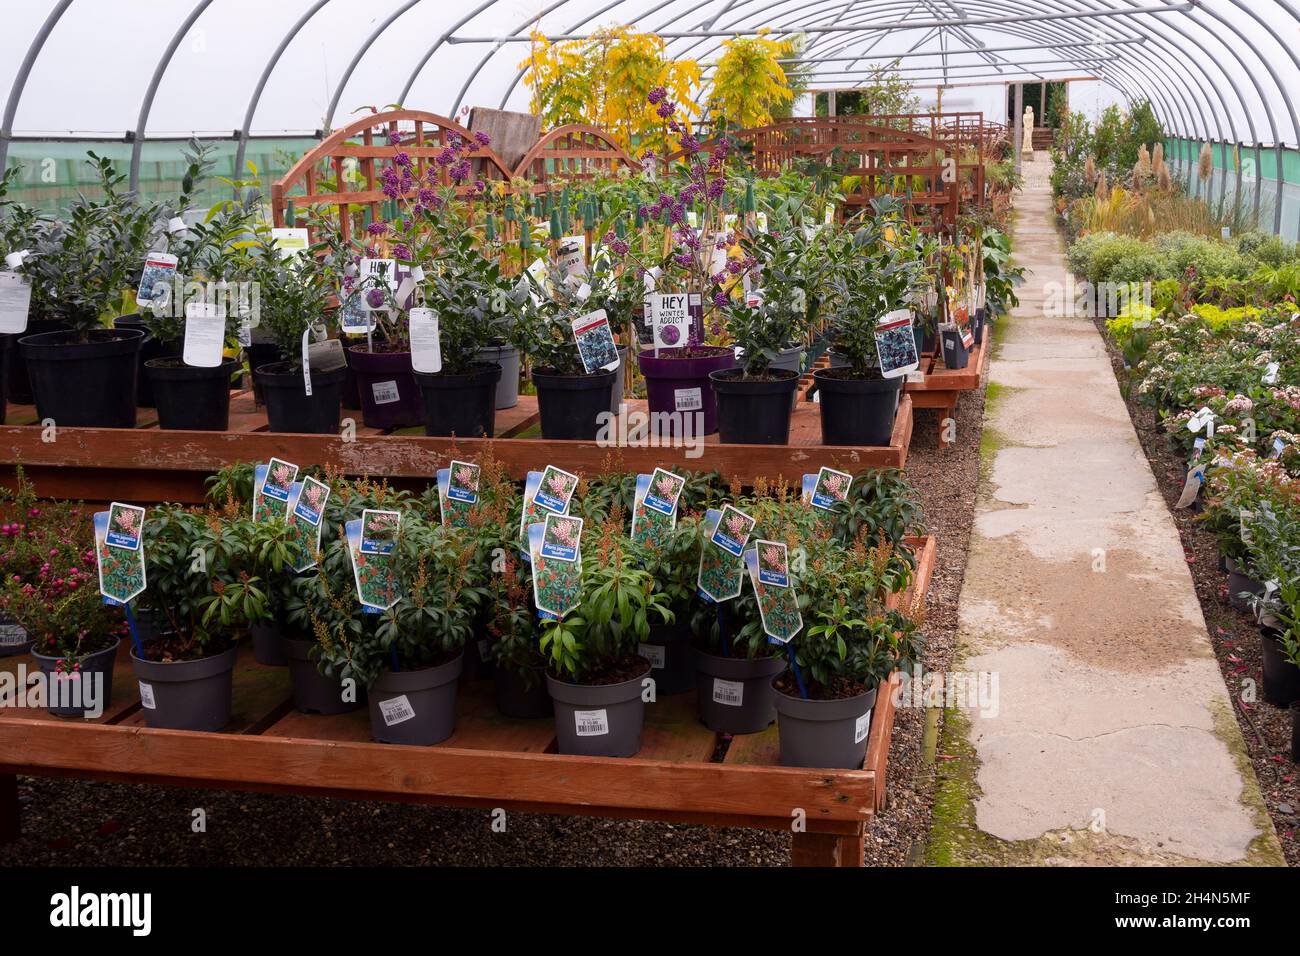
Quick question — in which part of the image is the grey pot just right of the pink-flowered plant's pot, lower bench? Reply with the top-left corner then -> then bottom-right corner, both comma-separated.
131,648 -> 239,731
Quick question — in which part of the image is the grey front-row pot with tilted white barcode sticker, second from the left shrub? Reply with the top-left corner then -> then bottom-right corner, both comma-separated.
369,652 -> 465,747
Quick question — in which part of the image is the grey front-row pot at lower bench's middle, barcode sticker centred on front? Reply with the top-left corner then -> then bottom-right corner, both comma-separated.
546,670 -> 649,757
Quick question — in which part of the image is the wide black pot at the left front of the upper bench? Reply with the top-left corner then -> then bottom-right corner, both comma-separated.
18,329 -> 144,428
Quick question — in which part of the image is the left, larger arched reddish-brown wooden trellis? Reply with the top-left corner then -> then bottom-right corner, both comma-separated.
270,109 -> 511,238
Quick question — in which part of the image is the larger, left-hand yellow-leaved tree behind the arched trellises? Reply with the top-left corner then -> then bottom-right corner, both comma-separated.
519,26 -> 701,153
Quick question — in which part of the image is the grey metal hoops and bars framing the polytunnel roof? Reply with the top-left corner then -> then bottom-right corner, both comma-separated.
0,0 -> 1300,232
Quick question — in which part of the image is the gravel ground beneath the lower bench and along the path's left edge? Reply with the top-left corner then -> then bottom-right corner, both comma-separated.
0,392 -> 982,866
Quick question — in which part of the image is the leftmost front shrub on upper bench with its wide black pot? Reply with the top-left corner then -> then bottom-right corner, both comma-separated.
18,153 -> 157,428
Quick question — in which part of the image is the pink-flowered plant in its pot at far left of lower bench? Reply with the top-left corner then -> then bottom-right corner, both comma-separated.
0,470 -> 125,717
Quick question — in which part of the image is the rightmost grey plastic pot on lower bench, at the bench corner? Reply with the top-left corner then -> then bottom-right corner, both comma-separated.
772,687 -> 876,770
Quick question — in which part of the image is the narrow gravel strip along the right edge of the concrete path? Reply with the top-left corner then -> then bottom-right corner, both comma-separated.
1097,321 -> 1300,866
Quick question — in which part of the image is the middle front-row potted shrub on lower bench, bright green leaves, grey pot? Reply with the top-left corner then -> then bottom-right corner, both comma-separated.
533,518 -> 672,757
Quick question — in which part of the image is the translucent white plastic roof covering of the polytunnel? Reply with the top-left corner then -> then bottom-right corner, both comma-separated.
0,0 -> 1300,150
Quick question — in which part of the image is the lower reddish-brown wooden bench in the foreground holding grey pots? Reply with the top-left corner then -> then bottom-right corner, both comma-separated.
0,537 -> 936,866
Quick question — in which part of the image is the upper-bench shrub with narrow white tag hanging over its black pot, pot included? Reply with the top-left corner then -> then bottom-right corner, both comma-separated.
252,223 -> 346,434
